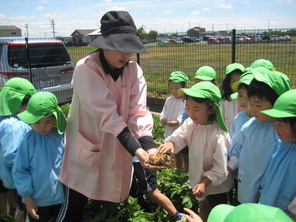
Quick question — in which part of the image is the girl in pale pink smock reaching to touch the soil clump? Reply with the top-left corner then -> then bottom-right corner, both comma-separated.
159,81 -> 232,221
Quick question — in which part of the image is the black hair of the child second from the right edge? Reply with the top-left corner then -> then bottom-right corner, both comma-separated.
248,79 -> 279,106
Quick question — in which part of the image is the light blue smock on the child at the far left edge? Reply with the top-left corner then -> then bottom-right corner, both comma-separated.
0,116 -> 31,189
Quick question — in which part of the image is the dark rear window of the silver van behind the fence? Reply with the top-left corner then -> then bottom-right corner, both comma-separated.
8,43 -> 71,68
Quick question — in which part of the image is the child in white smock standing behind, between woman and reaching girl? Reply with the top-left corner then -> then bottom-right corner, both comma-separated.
160,71 -> 188,169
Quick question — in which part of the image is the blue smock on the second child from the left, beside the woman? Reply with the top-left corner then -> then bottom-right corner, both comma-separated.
13,127 -> 64,207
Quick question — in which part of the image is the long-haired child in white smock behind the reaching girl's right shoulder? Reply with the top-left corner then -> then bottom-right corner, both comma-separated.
220,63 -> 245,129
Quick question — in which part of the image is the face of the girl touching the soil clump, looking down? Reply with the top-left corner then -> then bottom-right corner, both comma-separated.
186,97 -> 215,125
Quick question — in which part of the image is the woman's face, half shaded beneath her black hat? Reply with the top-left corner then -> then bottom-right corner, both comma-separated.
104,49 -> 133,69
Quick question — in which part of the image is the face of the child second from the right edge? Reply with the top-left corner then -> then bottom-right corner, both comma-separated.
249,96 -> 274,122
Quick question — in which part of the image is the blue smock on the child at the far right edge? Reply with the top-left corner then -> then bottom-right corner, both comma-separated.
259,140 -> 296,211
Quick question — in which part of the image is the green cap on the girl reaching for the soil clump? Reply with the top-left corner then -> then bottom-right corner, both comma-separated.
178,81 -> 228,131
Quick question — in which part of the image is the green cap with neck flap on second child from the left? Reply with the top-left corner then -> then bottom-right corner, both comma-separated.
17,92 -> 66,134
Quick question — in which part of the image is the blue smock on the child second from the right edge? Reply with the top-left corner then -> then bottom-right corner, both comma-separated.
233,117 -> 278,203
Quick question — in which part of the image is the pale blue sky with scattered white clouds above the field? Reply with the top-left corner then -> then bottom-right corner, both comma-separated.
0,0 -> 296,38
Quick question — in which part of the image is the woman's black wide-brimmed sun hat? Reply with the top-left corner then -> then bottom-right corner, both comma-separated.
90,11 -> 148,53
